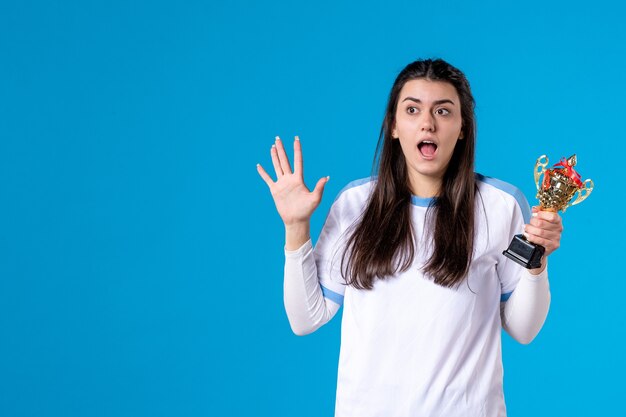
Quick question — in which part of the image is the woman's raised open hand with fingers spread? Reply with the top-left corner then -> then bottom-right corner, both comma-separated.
257,136 -> 330,227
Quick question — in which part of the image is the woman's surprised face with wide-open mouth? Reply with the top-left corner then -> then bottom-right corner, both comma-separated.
392,79 -> 462,192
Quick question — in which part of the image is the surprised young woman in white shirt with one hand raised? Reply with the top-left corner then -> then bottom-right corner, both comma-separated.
257,59 -> 562,417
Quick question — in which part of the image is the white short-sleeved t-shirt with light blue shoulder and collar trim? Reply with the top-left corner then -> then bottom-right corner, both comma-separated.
314,174 -> 530,417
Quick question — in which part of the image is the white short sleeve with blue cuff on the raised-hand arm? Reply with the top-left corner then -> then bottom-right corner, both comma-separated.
314,198 -> 346,305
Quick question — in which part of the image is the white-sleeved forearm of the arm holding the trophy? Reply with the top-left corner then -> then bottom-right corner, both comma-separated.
501,269 -> 550,344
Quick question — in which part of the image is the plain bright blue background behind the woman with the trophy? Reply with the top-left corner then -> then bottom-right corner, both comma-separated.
0,0 -> 626,417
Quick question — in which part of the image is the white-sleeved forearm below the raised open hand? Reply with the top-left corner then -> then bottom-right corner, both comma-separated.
284,239 -> 339,336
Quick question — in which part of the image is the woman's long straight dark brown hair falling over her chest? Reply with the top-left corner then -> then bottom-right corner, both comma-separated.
341,59 -> 476,289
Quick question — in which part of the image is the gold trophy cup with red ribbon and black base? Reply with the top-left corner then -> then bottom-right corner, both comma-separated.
502,155 -> 593,269
